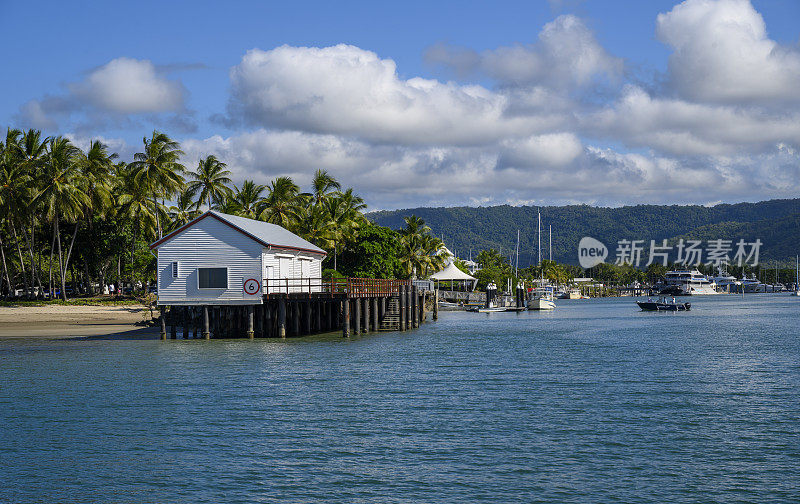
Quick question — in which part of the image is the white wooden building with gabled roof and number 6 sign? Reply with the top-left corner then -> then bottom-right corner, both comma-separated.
150,210 -> 326,305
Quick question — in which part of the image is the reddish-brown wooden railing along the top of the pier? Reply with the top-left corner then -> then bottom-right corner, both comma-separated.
261,278 -> 411,297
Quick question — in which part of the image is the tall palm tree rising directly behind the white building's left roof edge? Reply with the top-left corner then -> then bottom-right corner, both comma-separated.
129,131 -> 186,238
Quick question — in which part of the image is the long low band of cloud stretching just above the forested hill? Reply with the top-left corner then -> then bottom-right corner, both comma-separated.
182,129 -> 800,209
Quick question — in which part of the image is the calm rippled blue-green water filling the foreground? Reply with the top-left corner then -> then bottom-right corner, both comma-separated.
0,295 -> 800,503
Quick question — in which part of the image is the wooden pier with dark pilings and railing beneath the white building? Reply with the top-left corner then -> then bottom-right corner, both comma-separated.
160,278 -> 435,339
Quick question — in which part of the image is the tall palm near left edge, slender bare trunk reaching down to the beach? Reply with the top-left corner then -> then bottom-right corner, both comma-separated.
33,137 -> 91,301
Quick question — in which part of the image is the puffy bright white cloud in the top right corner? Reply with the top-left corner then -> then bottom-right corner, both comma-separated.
656,0 -> 800,104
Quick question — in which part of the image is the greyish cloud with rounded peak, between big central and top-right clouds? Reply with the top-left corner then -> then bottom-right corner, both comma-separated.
426,15 -> 623,88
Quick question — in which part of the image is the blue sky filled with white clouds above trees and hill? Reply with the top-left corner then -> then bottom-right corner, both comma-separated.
0,0 -> 800,208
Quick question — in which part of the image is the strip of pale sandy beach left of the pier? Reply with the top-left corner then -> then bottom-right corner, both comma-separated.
0,305 -> 158,339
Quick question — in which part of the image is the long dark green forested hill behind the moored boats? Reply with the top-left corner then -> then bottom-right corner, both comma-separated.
367,199 -> 800,266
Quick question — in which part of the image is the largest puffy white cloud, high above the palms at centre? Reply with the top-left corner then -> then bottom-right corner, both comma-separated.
223,45 -> 550,144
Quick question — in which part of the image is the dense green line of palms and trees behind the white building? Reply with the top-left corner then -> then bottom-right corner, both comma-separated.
0,128 -> 445,300
